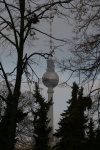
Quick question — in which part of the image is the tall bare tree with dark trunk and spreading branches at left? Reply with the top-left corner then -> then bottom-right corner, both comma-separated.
0,0 -> 72,150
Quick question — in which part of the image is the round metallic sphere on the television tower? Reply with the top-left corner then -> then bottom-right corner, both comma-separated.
42,71 -> 59,88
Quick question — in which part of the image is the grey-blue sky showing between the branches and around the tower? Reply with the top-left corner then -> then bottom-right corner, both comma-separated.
0,1 -> 76,129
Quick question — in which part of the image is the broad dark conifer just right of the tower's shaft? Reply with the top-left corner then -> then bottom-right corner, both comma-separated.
55,83 -> 91,150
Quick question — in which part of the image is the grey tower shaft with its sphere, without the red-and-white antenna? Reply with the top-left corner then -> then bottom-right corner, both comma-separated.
42,58 -> 59,134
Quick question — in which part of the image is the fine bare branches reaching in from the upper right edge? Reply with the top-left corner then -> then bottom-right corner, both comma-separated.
57,0 -> 100,91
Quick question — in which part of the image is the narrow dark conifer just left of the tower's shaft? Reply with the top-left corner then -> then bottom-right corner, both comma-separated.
33,83 -> 52,150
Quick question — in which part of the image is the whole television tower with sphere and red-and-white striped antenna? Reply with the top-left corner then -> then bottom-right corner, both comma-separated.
42,5 -> 59,137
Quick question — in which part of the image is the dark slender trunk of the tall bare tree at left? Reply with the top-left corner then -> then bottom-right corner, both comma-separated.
7,0 -> 25,150
